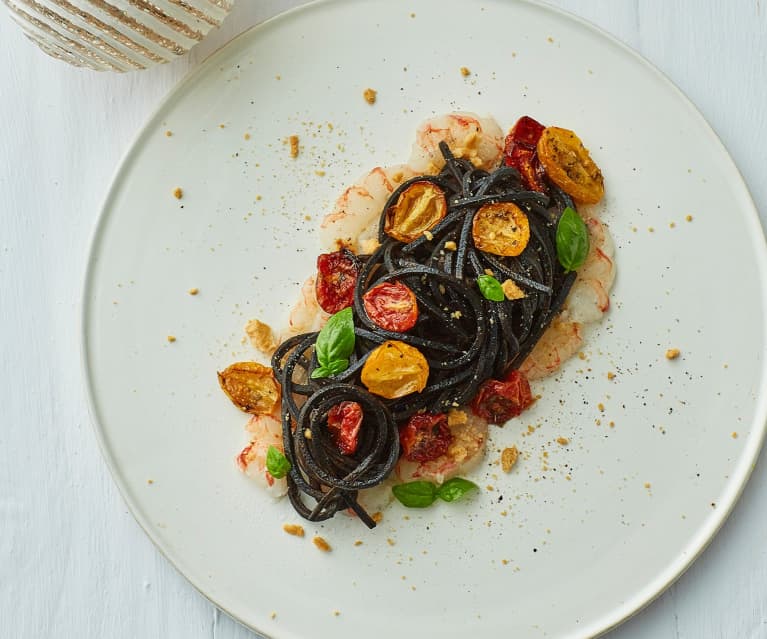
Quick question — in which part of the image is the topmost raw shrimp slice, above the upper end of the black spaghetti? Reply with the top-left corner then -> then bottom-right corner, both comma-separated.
408,112 -> 504,174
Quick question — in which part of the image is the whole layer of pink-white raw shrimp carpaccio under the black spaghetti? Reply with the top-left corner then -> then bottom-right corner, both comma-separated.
230,112 -> 615,513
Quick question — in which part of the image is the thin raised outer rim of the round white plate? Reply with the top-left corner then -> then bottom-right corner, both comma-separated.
78,0 -> 767,639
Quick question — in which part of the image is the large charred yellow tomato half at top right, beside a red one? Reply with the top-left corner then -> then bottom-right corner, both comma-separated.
537,126 -> 605,204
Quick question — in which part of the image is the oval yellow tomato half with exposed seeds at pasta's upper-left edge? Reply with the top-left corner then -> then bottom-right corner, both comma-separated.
384,181 -> 447,243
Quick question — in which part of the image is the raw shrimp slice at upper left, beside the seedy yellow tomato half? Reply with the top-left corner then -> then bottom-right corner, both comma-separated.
320,164 -> 415,253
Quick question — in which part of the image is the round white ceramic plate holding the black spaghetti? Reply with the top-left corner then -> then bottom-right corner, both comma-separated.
84,0 -> 767,639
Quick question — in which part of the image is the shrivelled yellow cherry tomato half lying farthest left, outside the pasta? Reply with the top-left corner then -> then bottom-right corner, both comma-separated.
218,362 -> 280,415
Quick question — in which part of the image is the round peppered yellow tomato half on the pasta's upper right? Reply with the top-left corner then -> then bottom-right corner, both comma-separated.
471,202 -> 530,257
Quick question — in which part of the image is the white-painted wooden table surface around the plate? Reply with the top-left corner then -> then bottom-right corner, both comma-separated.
0,0 -> 767,639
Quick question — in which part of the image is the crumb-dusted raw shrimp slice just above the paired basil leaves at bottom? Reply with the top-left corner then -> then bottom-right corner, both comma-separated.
395,408 -> 487,484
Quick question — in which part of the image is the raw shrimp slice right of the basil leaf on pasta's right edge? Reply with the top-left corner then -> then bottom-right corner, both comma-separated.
562,218 -> 615,323
